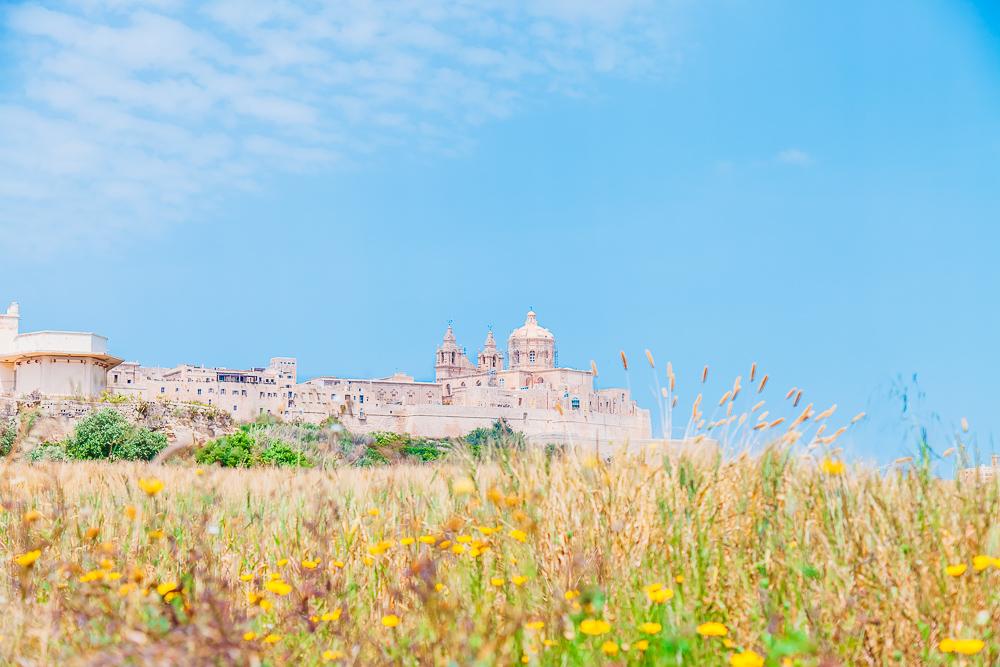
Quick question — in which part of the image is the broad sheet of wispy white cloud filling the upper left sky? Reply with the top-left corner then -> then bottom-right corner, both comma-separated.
0,0 -> 666,249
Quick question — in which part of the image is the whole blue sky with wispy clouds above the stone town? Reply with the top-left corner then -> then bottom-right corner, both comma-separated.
0,0 -> 1000,462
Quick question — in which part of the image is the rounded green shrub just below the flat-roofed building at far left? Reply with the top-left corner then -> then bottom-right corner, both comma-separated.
64,408 -> 167,461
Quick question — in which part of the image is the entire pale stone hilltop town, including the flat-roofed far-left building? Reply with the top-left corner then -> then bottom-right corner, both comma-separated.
0,303 -> 651,443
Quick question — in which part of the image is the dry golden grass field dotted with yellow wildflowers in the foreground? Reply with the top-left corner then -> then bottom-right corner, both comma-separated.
0,444 -> 1000,665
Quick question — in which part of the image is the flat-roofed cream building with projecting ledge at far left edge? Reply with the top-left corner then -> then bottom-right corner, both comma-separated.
0,302 -> 121,398
